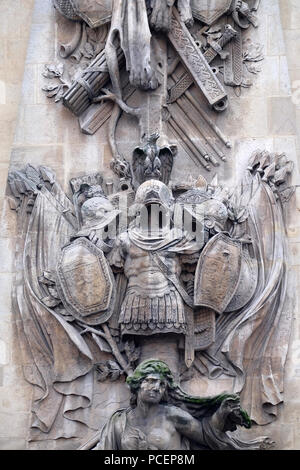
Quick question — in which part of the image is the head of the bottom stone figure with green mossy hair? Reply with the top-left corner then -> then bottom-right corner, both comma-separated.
126,359 -> 175,405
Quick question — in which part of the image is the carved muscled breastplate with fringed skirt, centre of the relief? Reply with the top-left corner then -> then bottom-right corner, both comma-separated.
111,233 -> 190,335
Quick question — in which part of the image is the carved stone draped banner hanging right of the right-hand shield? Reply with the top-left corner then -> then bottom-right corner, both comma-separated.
198,154 -> 292,425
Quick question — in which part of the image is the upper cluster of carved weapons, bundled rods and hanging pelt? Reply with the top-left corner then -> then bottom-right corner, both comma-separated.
43,0 -> 263,171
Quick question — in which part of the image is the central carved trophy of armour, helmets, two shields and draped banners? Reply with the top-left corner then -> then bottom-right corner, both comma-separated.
9,152 -> 292,446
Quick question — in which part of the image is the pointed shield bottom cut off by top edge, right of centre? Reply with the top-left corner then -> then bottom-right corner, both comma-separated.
191,0 -> 232,25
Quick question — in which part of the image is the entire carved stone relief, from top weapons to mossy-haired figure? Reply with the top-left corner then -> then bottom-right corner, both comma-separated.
8,0 -> 293,449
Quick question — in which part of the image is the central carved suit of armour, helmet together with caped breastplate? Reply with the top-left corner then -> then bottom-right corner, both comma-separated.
108,180 -> 200,335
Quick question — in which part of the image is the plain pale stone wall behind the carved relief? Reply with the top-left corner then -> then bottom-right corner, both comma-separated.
0,0 -> 300,449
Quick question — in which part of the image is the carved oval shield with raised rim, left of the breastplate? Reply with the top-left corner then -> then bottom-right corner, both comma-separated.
57,238 -> 115,325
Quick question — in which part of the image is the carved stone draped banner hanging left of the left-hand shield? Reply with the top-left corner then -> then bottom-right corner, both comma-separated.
9,165 -> 93,440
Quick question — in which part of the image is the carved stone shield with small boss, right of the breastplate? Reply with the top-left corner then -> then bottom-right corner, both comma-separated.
194,233 -> 242,313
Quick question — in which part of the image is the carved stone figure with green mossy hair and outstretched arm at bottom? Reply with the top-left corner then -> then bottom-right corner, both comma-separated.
81,360 -> 271,450
